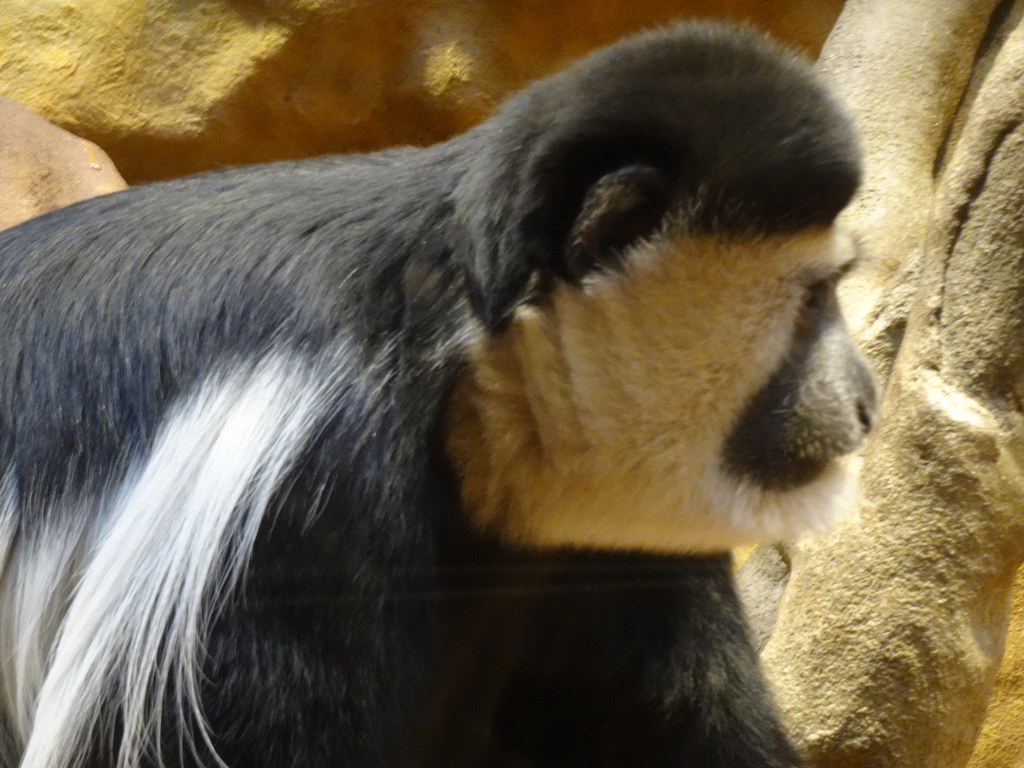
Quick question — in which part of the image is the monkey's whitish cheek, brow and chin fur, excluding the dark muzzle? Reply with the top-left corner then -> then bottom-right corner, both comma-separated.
450,230 -> 856,552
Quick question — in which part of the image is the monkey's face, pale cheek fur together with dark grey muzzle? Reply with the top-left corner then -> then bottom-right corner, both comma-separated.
450,222 -> 874,551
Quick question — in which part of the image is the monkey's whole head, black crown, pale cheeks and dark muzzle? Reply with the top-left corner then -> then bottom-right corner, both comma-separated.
449,25 -> 874,551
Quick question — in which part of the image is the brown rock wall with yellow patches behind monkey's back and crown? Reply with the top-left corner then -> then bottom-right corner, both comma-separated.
0,0 -> 842,182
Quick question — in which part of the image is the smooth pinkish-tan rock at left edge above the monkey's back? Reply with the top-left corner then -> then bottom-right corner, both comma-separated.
0,97 -> 125,229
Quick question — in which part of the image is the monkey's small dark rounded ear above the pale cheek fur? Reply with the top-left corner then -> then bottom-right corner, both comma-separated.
563,165 -> 672,282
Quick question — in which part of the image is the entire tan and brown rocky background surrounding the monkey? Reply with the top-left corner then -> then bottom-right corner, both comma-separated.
0,0 -> 1024,768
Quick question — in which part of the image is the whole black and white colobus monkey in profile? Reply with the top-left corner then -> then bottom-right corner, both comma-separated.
0,25 -> 873,768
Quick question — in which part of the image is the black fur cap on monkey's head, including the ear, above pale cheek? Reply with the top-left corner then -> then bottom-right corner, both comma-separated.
455,24 -> 860,327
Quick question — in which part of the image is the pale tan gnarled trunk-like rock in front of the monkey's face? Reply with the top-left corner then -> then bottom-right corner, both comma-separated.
740,0 -> 1024,768
